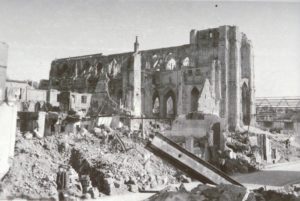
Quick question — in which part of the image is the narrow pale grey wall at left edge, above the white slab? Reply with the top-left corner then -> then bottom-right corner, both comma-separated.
0,42 -> 8,103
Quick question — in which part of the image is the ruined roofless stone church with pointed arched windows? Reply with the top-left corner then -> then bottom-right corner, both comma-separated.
49,26 -> 255,129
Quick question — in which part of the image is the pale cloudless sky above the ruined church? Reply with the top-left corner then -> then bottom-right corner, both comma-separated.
0,0 -> 300,96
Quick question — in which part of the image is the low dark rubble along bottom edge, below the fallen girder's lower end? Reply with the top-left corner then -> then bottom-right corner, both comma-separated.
146,184 -> 300,201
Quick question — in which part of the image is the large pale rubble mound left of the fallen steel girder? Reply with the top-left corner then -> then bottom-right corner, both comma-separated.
0,130 -> 176,199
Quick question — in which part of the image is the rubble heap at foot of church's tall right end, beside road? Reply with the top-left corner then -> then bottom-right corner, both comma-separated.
220,130 -> 300,174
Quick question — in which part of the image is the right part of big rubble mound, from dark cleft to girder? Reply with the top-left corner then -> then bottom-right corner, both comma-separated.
70,133 -> 176,195
